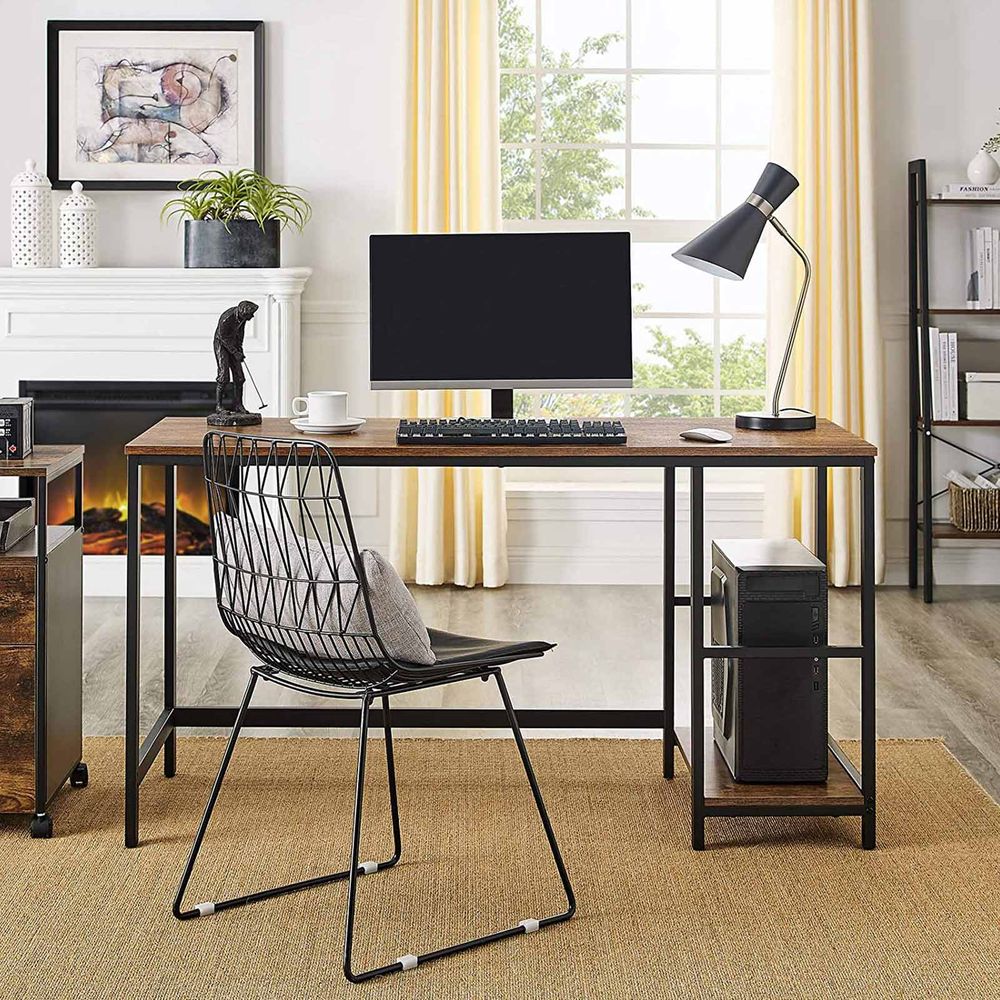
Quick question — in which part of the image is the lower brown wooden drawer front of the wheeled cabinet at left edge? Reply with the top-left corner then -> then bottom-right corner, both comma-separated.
0,646 -> 35,812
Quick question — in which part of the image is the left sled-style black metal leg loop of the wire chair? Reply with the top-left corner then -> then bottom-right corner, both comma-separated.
173,673 -> 402,920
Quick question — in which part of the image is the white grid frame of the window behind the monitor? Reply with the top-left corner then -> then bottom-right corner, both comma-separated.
500,0 -> 771,428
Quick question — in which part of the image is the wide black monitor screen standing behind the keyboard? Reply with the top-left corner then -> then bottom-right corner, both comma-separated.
370,233 -> 632,389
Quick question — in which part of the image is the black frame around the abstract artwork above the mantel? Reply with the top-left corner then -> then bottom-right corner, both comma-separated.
46,20 -> 265,191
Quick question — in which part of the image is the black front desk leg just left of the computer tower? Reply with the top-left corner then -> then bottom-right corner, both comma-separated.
690,467 -> 705,851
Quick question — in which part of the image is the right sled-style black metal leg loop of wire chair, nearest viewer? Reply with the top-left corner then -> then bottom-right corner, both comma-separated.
344,670 -> 576,983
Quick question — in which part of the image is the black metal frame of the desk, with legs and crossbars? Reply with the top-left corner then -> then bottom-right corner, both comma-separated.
125,448 -> 875,850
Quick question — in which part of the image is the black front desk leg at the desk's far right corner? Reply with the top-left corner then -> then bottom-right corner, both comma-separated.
861,458 -> 875,850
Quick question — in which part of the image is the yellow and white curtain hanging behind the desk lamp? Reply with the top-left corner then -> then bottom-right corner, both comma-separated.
766,0 -> 885,586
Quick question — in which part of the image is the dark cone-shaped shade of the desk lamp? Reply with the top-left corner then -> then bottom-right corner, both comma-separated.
674,163 -> 799,281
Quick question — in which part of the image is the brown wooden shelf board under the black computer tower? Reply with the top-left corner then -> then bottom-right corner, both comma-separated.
677,729 -> 864,807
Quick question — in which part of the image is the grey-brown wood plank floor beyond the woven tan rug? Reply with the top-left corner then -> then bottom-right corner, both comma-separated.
84,585 -> 1000,801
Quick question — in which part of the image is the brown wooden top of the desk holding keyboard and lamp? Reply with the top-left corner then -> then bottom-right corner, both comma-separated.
125,417 -> 876,465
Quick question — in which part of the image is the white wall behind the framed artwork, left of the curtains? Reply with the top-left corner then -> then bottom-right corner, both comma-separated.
0,0 -> 402,544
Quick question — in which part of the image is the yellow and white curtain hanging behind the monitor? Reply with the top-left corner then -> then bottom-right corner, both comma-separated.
389,0 -> 507,587
